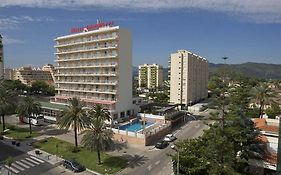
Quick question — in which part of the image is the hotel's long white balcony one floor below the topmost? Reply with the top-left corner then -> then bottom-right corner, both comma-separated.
55,44 -> 117,55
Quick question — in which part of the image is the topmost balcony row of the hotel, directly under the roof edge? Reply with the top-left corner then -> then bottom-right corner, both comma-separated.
55,35 -> 118,47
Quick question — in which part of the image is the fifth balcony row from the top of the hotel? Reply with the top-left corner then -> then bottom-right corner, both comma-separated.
55,72 -> 117,77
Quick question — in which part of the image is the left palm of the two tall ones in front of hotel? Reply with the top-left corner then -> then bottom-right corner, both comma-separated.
57,97 -> 88,148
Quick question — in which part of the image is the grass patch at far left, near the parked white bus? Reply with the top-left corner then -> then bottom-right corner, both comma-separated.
0,124 -> 41,141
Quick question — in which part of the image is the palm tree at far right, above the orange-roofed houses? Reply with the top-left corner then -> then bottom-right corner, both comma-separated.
252,83 -> 273,118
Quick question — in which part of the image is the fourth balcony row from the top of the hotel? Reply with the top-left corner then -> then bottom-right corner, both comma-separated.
55,62 -> 118,69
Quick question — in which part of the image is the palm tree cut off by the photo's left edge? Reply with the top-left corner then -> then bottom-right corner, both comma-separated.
0,86 -> 15,131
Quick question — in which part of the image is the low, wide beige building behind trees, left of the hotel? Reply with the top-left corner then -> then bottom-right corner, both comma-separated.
14,67 -> 54,85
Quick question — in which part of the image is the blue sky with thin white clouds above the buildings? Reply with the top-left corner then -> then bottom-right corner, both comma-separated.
0,0 -> 281,68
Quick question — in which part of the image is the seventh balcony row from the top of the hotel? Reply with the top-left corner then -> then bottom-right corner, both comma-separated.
56,87 -> 117,95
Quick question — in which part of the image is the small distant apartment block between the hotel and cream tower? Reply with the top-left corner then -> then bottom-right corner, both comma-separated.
139,64 -> 163,89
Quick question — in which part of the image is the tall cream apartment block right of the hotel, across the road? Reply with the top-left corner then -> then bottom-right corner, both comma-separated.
169,50 -> 208,106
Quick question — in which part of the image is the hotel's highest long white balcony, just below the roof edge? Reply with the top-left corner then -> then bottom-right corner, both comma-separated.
55,36 -> 118,48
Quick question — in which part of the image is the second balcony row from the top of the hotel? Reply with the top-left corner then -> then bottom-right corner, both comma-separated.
55,44 -> 117,54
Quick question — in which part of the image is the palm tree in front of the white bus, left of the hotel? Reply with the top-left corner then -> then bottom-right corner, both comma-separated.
16,96 -> 41,134
